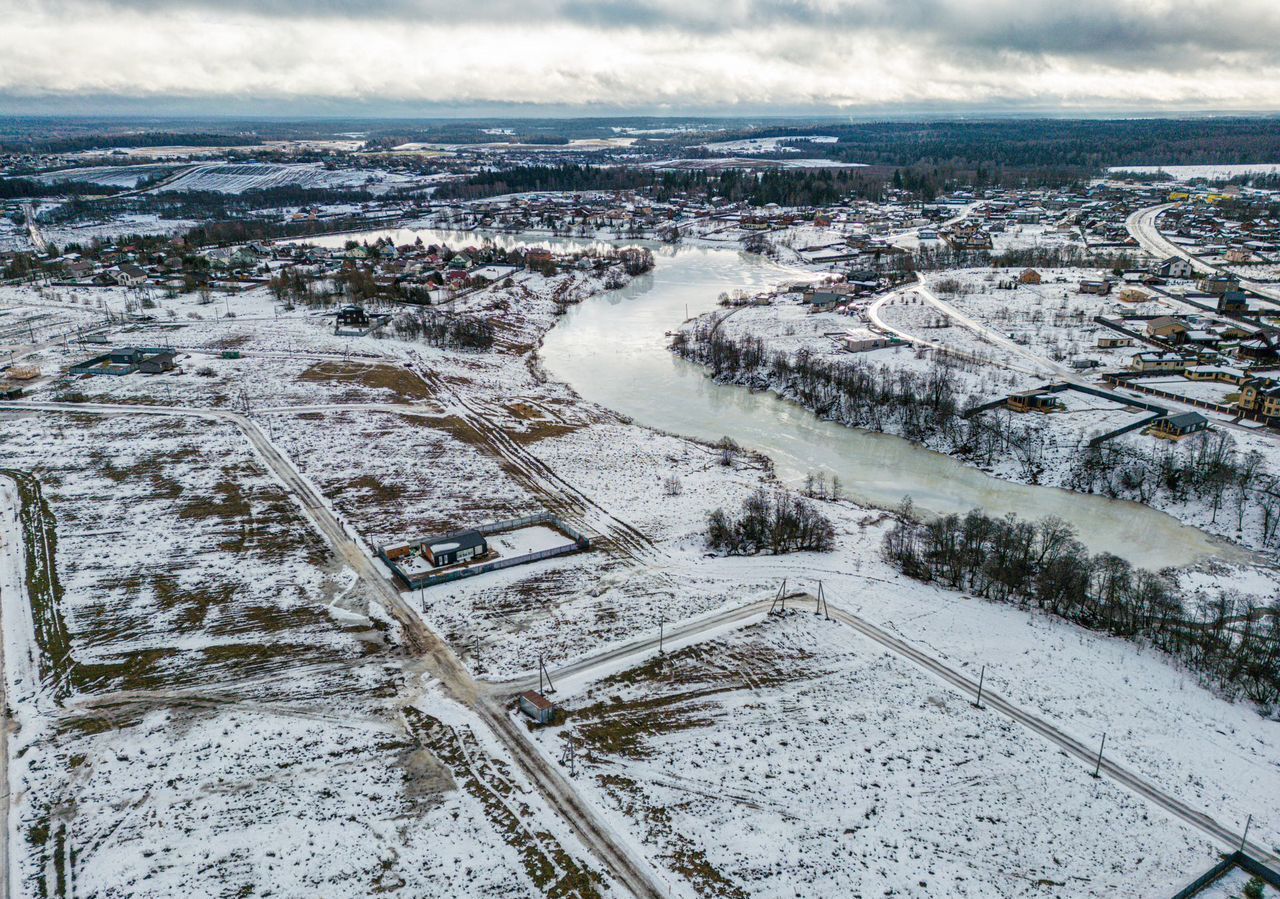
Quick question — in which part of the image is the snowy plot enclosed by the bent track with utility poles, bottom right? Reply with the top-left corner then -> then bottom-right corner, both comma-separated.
536,611 -> 1216,896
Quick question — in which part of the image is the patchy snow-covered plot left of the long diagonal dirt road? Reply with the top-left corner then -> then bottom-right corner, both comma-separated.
0,414 -> 604,899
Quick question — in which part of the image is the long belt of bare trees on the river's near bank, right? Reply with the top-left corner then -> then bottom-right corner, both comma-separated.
883,507 -> 1280,706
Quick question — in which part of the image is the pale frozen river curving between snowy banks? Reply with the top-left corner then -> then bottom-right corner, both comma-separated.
304,229 -> 1243,567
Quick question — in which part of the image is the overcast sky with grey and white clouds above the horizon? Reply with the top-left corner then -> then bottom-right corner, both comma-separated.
0,0 -> 1280,114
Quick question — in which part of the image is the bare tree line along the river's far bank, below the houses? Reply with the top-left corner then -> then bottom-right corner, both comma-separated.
672,327 -> 1280,548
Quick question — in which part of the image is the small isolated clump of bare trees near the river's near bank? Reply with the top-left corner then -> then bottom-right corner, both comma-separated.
707,489 -> 836,556
